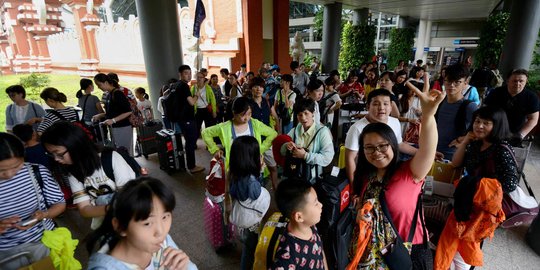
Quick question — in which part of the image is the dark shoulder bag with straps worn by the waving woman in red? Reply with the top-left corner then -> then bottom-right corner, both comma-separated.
380,190 -> 428,269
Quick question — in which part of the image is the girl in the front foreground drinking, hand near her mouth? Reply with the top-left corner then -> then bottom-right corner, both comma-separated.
86,177 -> 197,270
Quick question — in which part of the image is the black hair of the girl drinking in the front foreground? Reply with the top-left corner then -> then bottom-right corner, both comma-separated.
86,177 -> 176,253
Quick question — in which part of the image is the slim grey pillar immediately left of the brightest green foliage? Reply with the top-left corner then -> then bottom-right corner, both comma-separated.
322,3 -> 342,73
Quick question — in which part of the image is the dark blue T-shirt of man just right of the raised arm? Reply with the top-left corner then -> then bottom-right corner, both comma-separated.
437,99 -> 477,160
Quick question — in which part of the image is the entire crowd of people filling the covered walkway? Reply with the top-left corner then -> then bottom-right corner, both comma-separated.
0,58 -> 540,269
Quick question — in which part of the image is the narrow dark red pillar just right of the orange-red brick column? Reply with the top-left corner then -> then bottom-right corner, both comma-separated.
273,0 -> 292,71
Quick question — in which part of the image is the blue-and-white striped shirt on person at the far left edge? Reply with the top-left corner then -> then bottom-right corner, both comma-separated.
0,163 -> 65,250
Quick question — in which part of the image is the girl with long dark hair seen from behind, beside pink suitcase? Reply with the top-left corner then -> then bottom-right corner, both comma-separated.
228,136 -> 270,270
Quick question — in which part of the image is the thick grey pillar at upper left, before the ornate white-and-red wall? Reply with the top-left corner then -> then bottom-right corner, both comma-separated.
135,0 -> 184,115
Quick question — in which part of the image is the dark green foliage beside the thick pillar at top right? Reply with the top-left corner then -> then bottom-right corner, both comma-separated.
474,12 -> 510,67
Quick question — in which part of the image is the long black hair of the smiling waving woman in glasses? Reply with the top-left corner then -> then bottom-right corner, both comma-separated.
353,122 -> 399,194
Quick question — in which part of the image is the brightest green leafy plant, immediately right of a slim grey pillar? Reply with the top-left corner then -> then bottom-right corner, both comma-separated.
339,22 -> 377,74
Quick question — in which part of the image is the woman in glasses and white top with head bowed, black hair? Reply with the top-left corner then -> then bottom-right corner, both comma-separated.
41,122 -> 135,229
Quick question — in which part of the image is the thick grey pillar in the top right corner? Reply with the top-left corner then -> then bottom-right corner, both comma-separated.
499,0 -> 540,76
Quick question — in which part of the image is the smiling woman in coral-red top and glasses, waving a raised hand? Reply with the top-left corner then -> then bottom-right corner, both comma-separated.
351,79 -> 445,269
